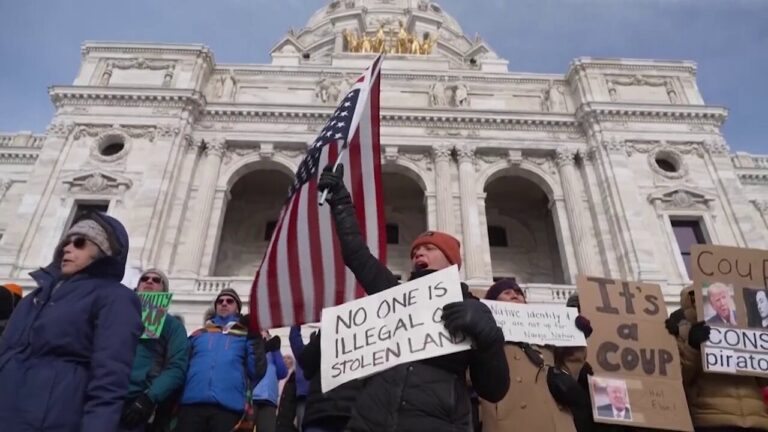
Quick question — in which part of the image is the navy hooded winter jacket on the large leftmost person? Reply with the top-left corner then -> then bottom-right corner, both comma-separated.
0,213 -> 142,432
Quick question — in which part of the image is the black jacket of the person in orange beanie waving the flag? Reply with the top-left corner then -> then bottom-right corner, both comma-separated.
330,190 -> 509,432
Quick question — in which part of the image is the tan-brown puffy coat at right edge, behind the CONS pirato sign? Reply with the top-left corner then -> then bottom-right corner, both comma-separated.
677,287 -> 768,430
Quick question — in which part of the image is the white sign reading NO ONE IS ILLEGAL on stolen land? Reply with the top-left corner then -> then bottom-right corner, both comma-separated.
320,266 -> 470,392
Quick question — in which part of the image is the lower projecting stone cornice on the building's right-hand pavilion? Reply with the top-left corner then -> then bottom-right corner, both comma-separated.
576,102 -> 728,126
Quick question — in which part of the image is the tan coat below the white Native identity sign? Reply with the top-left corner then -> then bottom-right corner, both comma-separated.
480,343 -> 580,432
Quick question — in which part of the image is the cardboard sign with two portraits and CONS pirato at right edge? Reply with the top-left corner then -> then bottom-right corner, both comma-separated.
691,245 -> 768,377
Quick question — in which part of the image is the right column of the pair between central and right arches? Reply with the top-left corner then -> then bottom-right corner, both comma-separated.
457,144 -> 490,280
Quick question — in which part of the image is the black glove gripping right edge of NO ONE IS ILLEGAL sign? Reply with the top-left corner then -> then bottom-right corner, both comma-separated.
443,300 -> 504,350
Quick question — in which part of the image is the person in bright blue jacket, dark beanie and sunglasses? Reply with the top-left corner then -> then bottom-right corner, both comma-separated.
178,288 -> 267,432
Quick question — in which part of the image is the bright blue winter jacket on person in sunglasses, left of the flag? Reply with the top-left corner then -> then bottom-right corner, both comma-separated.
181,315 -> 263,412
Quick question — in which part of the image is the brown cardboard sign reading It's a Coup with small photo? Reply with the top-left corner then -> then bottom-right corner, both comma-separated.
577,275 -> 693,431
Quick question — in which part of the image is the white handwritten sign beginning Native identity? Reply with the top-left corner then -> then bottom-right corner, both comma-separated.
482,300 -> 587,346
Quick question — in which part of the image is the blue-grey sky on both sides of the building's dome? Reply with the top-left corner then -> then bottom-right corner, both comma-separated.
0,0 -> 768,154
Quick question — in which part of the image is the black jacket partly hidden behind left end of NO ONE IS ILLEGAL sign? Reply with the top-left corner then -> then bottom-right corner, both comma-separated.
296,330 -> 363,430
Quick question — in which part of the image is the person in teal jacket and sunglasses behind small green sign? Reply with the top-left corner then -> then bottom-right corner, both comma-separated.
120,269 -> 189,432
